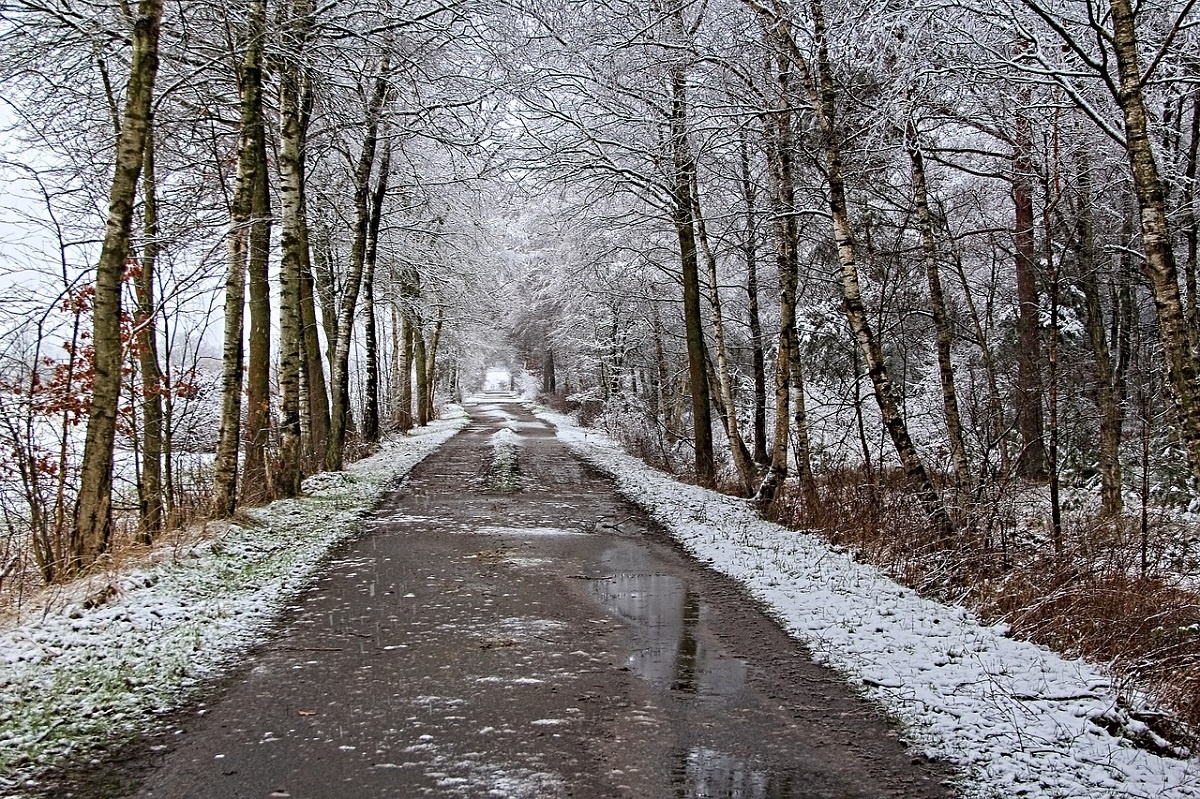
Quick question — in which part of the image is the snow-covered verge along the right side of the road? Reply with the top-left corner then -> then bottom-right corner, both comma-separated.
538,409 -> 1200,799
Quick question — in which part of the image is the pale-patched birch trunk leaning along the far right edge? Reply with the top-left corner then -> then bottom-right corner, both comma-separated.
1111,0 -> 1200,482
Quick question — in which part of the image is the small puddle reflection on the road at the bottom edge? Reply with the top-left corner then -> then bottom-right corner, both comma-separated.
671,746 -> 799,799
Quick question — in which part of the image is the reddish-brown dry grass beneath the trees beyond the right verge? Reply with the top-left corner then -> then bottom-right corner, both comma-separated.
775,470 -> 1200,749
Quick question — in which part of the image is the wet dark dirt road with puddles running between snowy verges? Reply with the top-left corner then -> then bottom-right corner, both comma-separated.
103,402 -> 948,799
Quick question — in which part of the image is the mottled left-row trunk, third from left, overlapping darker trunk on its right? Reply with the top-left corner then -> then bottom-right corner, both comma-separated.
212,0 -> 266,518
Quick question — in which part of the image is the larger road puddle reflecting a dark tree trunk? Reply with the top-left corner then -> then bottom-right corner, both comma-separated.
592,547 -> 746,698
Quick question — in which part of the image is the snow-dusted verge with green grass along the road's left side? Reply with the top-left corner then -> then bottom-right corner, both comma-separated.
0,411 -> 468,797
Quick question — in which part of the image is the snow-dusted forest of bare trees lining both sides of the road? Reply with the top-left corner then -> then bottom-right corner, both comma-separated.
7,0 -> 1200,734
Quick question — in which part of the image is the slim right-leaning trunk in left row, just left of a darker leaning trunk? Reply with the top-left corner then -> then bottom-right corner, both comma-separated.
325,54 -> 390,471
